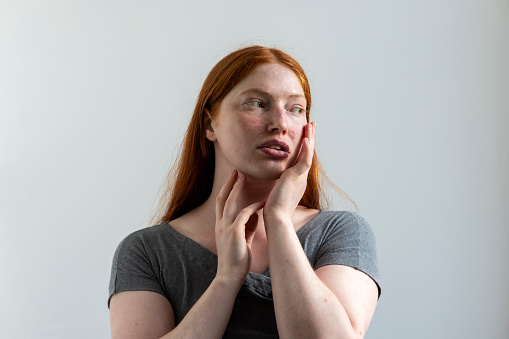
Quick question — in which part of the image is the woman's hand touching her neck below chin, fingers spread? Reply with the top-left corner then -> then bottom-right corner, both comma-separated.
215,170 -> 265,287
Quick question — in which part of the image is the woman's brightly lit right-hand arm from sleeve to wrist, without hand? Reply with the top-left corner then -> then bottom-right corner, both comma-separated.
265,219 -> 378,338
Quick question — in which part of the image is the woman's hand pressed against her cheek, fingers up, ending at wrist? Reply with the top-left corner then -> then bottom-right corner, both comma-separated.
263,122 -> 316,220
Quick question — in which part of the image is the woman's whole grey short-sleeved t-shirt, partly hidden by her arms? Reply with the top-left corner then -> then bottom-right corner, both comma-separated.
108,211 -> 380,338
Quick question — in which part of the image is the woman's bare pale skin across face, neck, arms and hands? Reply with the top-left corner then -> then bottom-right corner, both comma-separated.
110,64 -> 378,338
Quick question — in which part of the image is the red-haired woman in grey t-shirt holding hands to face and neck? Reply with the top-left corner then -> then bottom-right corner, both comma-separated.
109,46 -> 379,339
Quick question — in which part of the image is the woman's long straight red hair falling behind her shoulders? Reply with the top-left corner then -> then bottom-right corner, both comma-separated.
152,46 -> 350,223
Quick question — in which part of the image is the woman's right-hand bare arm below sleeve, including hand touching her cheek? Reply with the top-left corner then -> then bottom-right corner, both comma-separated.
263,123 -> 378,338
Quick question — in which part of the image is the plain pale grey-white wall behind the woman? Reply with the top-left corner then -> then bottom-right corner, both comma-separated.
0,0 -> 509,339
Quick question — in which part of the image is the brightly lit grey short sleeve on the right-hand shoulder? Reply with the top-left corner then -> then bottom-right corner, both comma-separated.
314,212 -> 381,295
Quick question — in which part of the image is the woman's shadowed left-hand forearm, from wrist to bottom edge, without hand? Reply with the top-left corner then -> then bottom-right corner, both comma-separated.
161,277 -> 240,339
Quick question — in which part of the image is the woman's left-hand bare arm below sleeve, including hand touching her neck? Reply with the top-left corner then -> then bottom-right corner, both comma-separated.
110,171 -> 264,339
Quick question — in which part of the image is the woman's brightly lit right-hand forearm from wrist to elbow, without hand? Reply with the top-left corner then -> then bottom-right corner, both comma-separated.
264,217 -> 359,338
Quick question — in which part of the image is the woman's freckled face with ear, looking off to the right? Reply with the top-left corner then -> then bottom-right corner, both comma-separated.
206,64 -> 307,180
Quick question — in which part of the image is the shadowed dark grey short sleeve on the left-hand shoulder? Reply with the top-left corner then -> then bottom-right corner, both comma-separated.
108,232 -> 164,307
